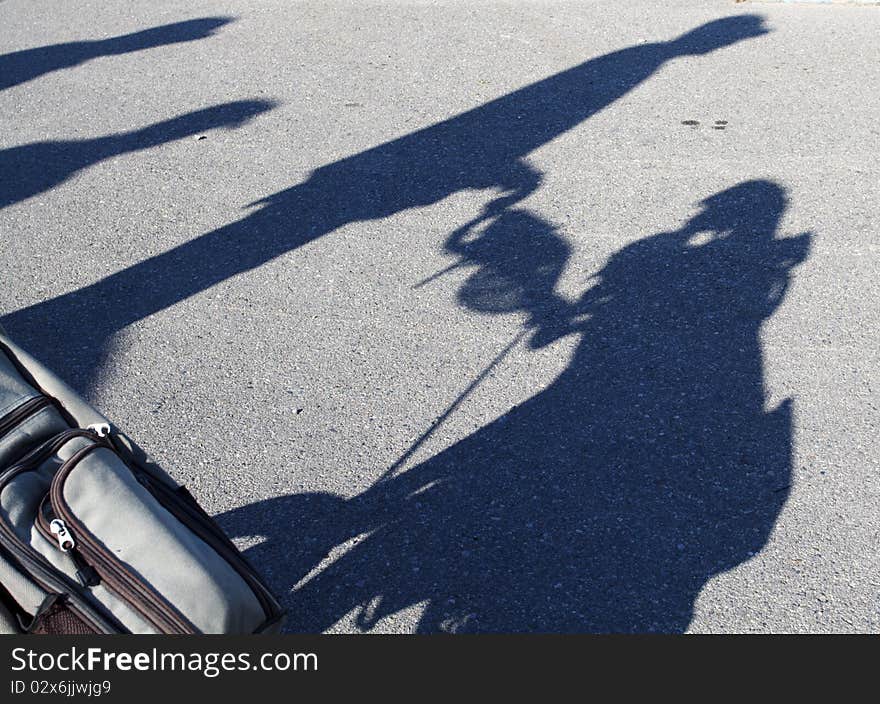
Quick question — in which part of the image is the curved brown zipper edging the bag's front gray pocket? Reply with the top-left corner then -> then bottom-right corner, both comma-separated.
45,442 -> 199,634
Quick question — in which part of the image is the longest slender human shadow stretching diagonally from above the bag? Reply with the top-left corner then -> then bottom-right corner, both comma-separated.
0,15 -> 767,392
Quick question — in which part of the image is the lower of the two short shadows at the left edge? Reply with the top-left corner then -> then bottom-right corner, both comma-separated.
0,100 -> 274,208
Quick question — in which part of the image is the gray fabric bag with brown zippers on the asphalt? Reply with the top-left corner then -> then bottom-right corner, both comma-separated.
0,330 -> 283,633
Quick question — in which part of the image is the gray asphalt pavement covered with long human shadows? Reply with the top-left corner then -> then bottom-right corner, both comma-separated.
0,0 -> 880,632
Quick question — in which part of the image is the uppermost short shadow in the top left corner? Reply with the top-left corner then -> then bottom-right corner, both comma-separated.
0,17 -> 232,90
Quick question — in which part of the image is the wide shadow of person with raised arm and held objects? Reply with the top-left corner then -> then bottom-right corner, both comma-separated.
219,181 -> 810,632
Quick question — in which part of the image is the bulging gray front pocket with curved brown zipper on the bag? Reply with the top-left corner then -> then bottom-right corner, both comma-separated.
37,441 -> 280,633
